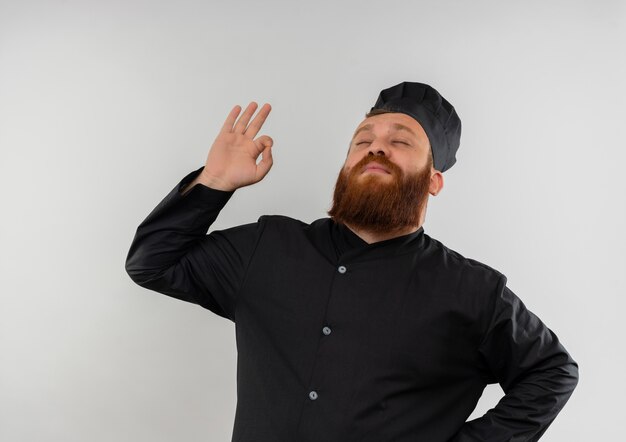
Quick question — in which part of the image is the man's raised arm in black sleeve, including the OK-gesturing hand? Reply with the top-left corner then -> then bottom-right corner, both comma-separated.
126,102 -> 272,321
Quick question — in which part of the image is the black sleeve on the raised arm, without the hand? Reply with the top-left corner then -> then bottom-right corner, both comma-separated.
126,166 -> 262,322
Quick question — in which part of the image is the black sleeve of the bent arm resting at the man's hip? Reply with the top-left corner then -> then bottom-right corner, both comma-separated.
452,276 -> 578,442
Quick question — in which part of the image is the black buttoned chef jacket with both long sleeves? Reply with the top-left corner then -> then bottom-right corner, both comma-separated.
126,167 -> 578,442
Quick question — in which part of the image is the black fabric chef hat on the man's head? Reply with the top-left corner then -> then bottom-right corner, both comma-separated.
370,81 -> 461,172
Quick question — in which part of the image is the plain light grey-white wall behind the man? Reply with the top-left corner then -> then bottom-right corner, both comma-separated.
0,0 -> 626,442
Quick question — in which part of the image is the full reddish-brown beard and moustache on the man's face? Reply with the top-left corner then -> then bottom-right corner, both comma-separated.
328,155 -> 430,234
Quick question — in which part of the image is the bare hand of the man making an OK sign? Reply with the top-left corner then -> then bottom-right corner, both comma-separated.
199,101 -> 274,191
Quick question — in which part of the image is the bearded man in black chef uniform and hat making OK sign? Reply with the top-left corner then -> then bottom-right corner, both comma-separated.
126,82 -> 578,442
